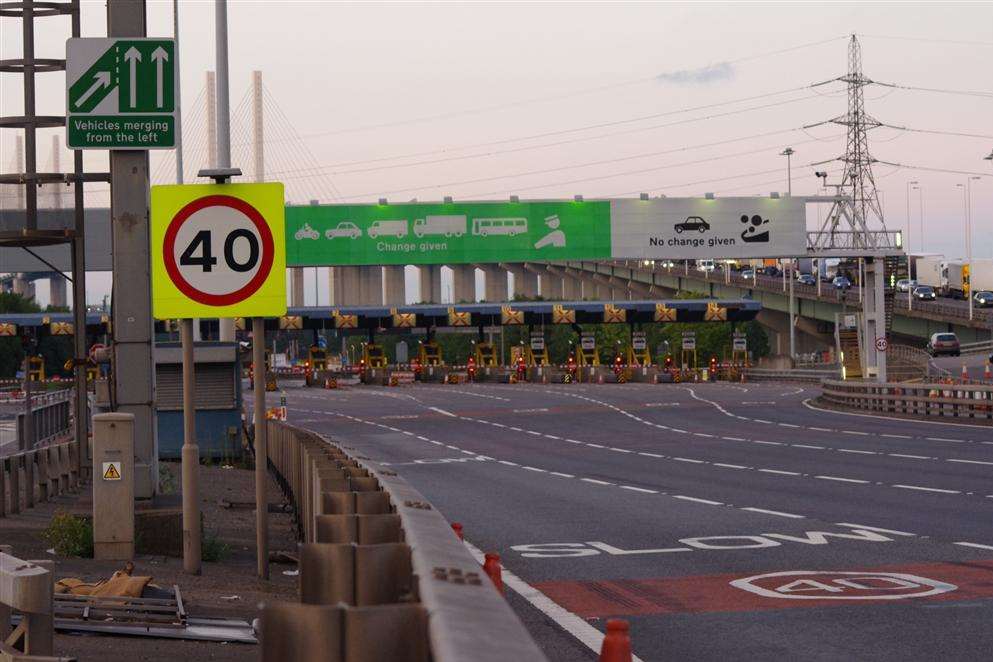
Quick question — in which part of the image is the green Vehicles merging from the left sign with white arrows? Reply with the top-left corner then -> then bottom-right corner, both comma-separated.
66,38 -> 179,149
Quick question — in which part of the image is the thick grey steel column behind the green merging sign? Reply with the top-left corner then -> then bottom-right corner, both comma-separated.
107,0 -> 159,499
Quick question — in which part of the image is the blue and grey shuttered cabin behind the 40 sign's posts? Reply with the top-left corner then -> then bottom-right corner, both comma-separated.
155,342 -> 242,459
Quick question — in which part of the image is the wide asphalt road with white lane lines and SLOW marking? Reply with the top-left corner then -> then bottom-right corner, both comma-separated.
268,384 -> 993,661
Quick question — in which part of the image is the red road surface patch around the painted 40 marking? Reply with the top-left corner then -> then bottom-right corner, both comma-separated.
536,560 -> 993,618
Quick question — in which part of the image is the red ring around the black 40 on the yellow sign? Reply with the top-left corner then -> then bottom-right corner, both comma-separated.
162,195 -> 276,306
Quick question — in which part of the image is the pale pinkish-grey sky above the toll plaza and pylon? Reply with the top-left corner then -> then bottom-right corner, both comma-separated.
0,1 -> 993,304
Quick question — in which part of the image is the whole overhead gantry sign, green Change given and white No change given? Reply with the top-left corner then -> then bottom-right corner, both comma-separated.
286,197 -> 807,267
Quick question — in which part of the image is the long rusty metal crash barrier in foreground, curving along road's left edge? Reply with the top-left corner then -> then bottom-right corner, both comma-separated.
261,421 -> 546,662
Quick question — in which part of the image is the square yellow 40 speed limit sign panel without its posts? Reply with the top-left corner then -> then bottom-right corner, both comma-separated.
151,183 -> 286,319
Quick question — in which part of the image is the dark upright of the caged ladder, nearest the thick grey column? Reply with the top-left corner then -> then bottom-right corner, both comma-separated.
70,0 -> 90,479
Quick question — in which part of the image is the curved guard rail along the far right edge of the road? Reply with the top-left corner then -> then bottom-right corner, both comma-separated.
820,380 -> 993,423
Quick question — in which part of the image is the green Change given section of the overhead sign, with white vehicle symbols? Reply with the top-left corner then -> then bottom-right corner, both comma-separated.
286,200 -> 611,266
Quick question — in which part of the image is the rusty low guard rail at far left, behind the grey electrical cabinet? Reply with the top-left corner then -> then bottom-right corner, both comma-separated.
0,439 -> 79,518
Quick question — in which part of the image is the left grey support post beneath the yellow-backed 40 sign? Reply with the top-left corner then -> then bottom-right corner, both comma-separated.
179,319 -> 203,575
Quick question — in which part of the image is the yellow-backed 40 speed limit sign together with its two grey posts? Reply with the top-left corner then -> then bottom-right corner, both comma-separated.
151,180 -> 286,578
